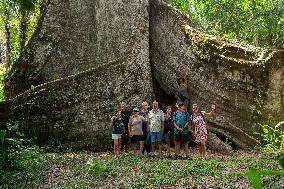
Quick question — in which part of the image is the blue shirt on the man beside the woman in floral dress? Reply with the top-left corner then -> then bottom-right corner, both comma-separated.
173,111 -> 189,134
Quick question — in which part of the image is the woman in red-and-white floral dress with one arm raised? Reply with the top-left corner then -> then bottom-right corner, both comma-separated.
190,104 -> 216,158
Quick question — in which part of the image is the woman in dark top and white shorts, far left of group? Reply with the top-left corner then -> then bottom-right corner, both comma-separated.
112,111 -> 124,155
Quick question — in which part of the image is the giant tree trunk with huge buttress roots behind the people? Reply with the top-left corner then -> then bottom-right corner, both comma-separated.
0,0 -> 284,151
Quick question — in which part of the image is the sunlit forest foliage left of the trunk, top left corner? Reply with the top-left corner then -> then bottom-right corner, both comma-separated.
0,0 -> 42,67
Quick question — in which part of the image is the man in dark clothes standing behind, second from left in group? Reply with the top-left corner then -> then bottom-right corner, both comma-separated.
120,101 -> 131,151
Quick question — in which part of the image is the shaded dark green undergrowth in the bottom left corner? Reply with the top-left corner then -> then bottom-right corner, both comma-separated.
0,122 -> 48,188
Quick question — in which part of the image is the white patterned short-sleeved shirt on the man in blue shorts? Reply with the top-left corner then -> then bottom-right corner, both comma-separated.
148,109 -> 165,132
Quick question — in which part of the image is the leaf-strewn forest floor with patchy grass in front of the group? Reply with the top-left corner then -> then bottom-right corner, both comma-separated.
30,150 -> 284,189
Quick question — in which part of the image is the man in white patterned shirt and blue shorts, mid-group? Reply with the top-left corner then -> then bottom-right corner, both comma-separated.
148,101 -> 164,157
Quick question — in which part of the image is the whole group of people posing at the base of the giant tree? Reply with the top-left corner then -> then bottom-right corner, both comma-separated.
111,78 -> 216,159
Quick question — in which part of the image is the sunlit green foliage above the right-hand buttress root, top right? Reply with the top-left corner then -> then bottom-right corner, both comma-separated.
167,0 -> 284,47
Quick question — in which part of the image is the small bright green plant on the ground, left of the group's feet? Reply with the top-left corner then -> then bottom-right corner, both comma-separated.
87,158 -> 109,176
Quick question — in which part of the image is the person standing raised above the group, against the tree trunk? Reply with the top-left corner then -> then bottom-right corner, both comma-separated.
176,77 -> 189,109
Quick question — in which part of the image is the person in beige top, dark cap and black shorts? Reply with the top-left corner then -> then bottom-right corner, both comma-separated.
128,107 -> 146,154
